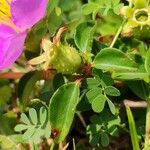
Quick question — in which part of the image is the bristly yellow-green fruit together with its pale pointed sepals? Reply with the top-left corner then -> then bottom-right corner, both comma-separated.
28,38 -> 81,74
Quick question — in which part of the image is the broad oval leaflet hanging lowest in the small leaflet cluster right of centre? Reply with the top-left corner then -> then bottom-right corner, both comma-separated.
92,94 -> 106,113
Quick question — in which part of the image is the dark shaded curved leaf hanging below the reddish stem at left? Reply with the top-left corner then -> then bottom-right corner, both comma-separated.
17,71 -> 42,109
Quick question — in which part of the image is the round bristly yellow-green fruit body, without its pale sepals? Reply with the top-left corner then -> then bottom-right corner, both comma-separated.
50,43 -> 81,74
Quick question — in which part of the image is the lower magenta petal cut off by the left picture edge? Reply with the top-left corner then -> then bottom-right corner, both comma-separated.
0,25 -> 27,69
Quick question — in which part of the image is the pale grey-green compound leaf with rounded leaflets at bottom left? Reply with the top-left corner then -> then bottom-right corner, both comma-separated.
15,107 -> 51,144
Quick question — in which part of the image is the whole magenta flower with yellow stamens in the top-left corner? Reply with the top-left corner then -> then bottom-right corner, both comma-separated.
0,0 -> 48,69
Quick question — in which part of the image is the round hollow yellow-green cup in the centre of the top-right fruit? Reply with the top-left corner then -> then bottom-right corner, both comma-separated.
134,9 -> 149,24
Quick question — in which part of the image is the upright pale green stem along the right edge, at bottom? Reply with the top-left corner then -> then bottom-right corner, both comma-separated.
144,100 -> 150,150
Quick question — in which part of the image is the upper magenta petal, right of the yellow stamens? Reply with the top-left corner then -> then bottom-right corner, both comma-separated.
11,0 -> 48,30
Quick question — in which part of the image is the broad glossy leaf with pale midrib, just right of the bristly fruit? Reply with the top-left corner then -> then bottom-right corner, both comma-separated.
93,48 -> 137,71
